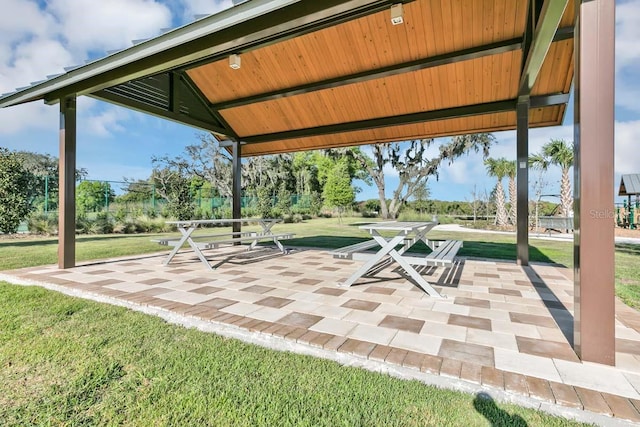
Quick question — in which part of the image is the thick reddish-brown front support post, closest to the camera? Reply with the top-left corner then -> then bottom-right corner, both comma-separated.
573,0 -> 615,365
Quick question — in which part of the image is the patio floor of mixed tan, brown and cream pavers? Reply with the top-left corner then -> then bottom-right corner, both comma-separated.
4,248 -> 640,422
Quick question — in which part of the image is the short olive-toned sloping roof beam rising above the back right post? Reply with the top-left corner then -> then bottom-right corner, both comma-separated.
518,0 -> 569,97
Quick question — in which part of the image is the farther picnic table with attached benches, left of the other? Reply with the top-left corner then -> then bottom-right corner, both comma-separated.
153,218 -> 294,270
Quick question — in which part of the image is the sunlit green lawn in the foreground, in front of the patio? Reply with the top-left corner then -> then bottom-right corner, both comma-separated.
0,282 -> 592,426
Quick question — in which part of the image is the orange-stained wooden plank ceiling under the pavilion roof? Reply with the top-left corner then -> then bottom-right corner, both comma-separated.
187,0 -> 575,156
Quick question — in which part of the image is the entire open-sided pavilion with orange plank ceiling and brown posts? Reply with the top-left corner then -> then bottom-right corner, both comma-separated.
0,0 -> 615,364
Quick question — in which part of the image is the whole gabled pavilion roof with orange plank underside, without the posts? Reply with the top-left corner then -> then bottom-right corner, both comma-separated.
0,0 -> 575,156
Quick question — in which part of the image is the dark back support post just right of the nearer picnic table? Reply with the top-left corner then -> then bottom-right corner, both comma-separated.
516,100 -> 529,265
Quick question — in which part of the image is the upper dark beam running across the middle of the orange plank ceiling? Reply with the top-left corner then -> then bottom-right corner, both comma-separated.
211,38 -> 522,110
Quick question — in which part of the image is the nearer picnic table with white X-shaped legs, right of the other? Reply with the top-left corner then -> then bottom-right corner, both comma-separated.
332,221 -> 462,298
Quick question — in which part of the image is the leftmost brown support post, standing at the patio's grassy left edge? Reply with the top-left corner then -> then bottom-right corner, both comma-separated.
58,95 -> 76,268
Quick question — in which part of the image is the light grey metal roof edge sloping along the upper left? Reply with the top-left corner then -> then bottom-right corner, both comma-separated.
0,0 -> 301,108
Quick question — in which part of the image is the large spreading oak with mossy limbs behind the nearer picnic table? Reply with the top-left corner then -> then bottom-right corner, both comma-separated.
348,133 -> 495,219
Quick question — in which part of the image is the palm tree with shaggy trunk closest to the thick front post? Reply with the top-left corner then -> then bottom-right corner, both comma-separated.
530,139 -> 574,217
